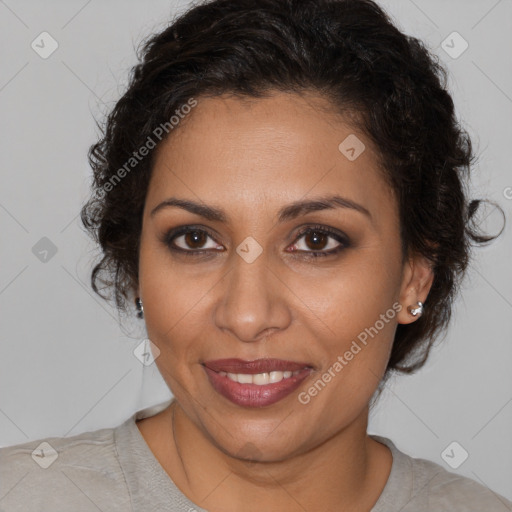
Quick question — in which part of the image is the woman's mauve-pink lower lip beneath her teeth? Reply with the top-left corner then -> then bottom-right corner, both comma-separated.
203,366 -> 311,407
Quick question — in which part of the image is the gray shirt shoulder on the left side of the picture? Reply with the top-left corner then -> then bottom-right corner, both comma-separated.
0,422 -> 130,512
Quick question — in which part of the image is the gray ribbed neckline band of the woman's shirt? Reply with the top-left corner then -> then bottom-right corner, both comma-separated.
114,399 -> 413,512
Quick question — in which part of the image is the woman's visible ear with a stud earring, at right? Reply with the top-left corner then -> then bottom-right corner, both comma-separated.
397,254 -> 434,324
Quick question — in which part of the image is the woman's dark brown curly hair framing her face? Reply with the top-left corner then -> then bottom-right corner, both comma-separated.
81,0 -> 502,375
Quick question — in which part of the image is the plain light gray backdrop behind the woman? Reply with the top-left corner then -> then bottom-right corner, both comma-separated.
0,0 -> 512,499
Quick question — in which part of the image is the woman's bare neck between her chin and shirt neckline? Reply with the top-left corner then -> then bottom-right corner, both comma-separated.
141,402 -> 392,512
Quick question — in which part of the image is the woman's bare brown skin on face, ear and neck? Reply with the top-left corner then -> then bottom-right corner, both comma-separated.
137,92 -> 433,512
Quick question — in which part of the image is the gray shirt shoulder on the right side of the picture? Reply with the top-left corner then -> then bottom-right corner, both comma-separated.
372,436 -> 512,512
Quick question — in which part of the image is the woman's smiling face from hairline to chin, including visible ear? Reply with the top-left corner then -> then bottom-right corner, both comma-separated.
138,93 -> 431,460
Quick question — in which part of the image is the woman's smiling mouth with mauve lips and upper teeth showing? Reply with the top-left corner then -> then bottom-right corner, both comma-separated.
203,359 -> 313,407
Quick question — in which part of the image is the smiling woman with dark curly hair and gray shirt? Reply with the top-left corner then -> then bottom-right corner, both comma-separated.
0,0 -> 512,512
